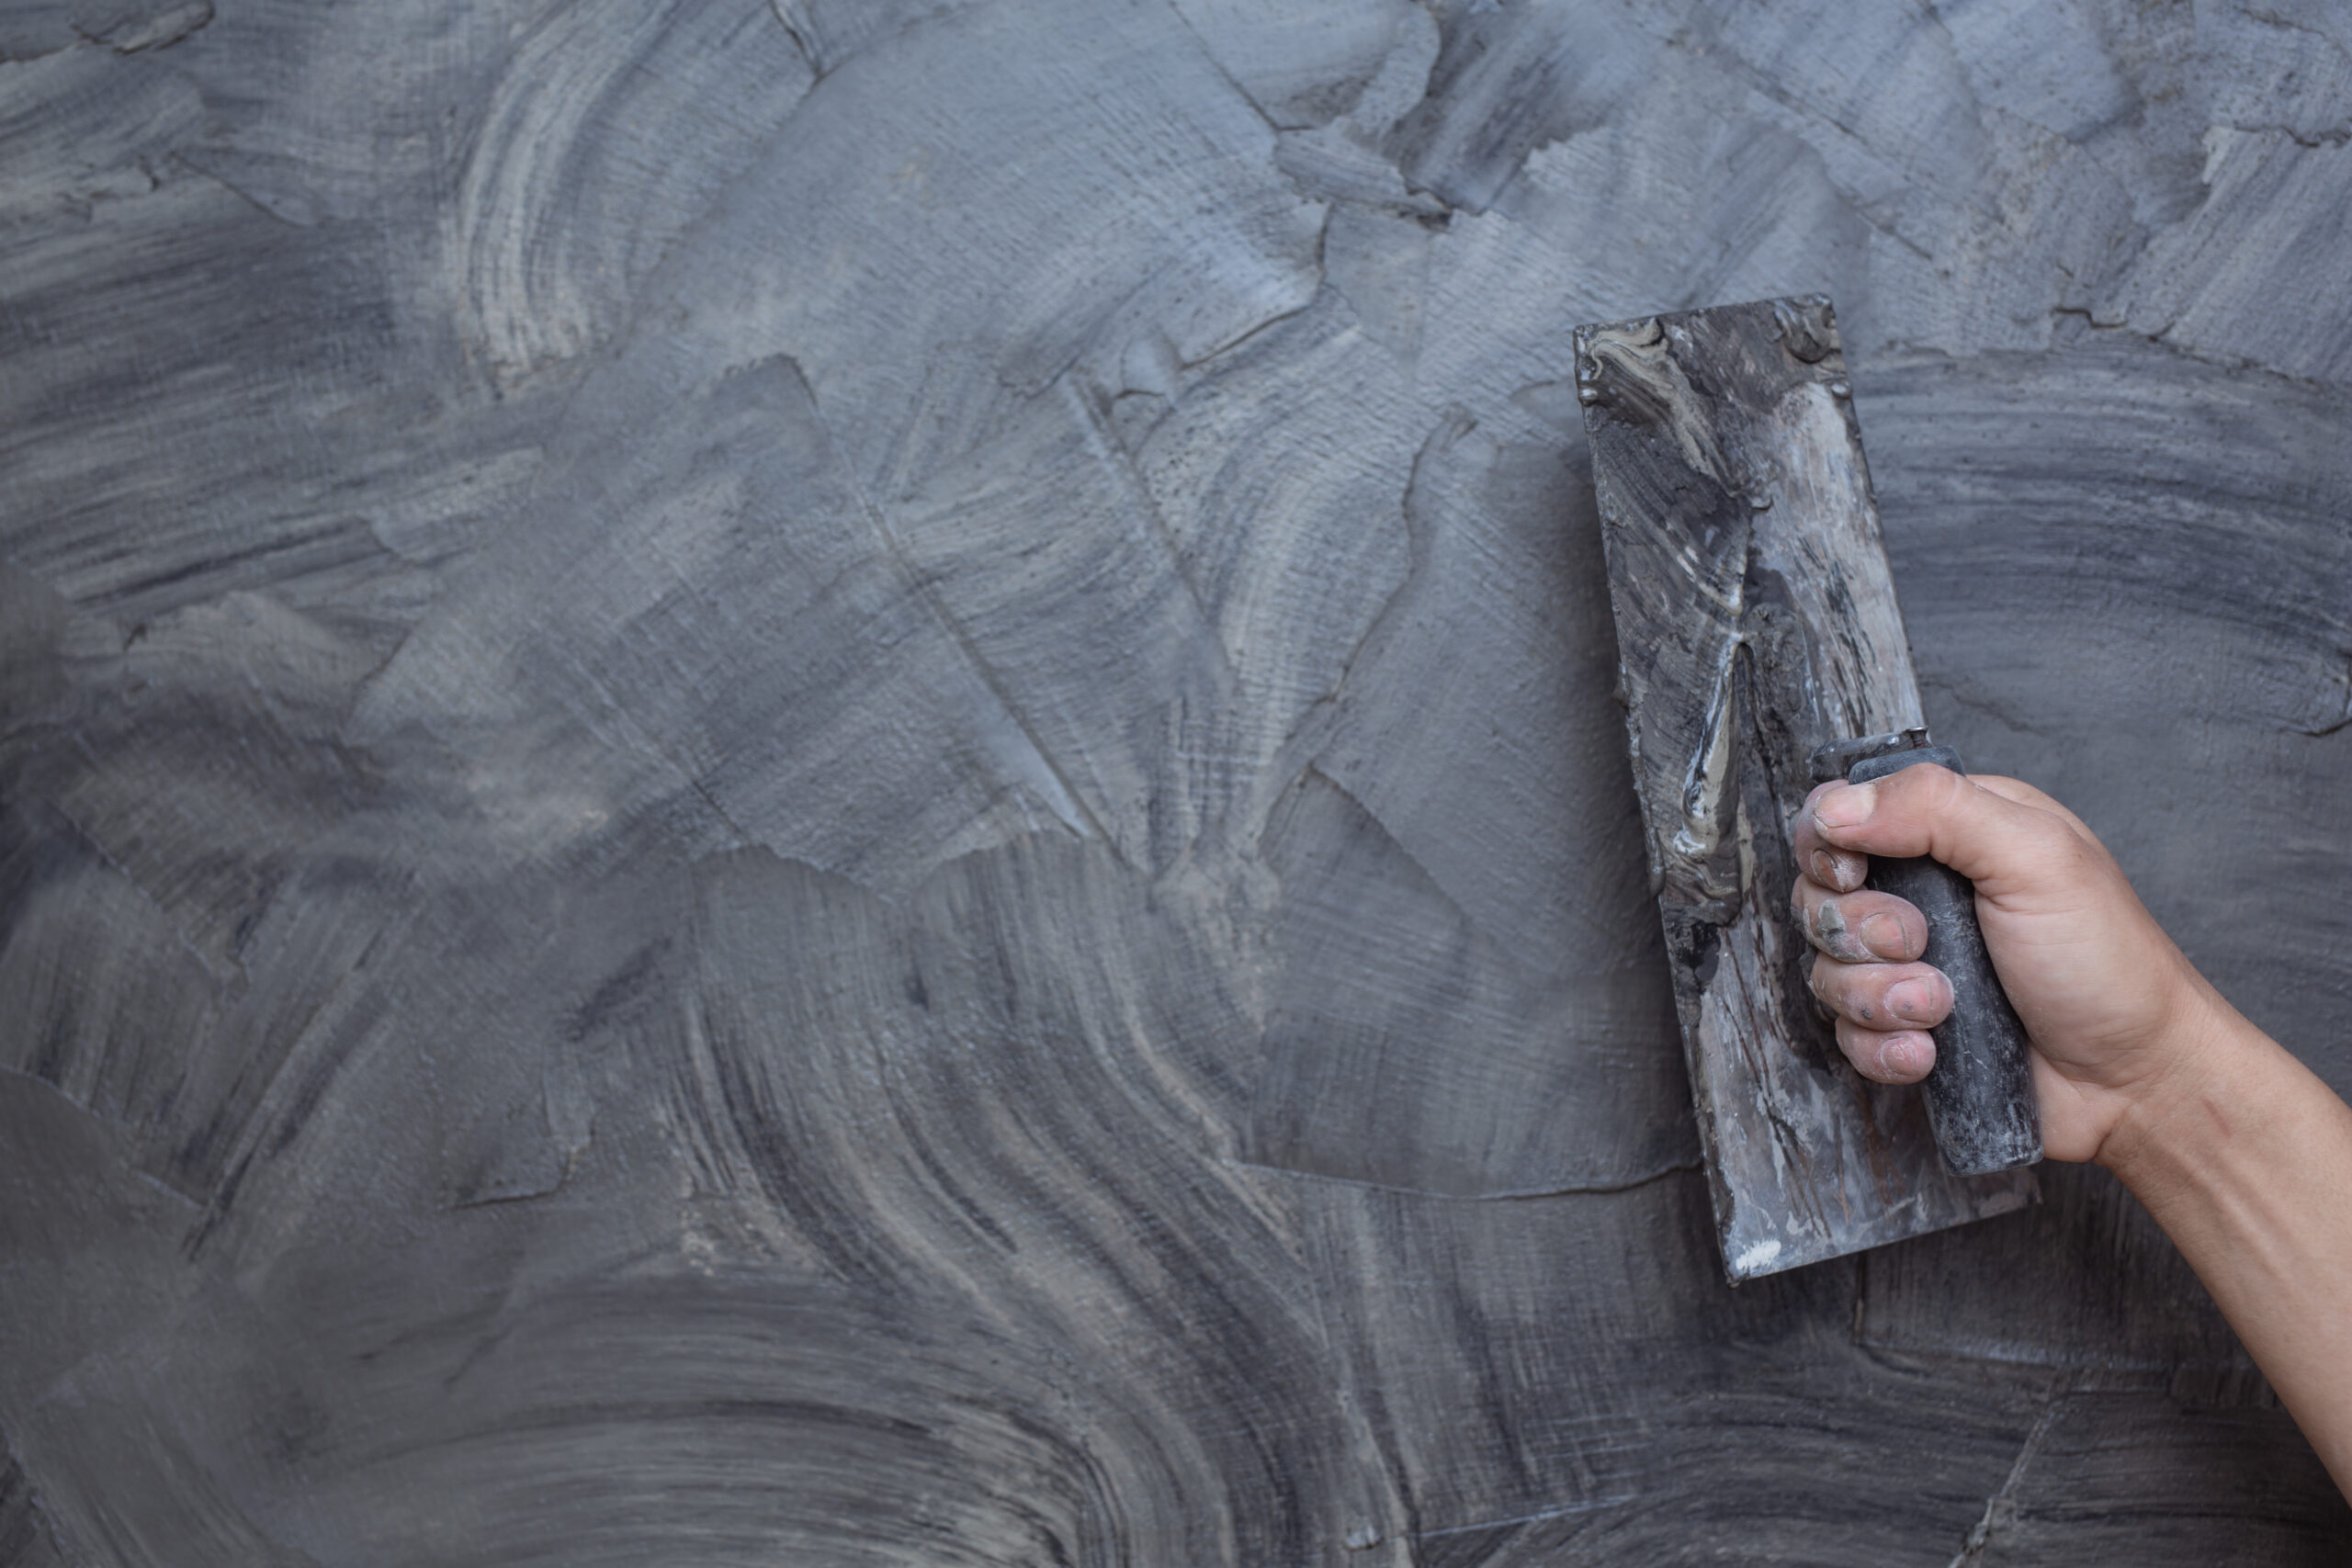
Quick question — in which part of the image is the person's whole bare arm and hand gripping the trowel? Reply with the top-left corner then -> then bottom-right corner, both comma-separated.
1790,761 -> 2352,1497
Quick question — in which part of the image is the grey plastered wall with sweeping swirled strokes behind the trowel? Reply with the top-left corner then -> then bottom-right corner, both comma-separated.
0,0 -> 2352,1568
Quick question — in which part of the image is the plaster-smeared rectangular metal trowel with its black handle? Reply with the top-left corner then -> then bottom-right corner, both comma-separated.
1576,294 -> 2041,1279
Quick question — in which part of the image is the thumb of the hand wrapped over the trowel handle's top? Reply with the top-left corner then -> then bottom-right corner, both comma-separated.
1806,761 -> 2082,896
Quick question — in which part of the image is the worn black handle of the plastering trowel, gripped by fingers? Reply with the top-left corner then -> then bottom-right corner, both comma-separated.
1847,745 -> 2041,1176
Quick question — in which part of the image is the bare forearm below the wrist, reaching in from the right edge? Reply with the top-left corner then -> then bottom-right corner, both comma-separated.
2098,992 -> 2352,1497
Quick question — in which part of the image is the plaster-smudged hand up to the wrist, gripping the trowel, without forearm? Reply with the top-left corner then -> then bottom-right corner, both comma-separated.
1790,764 -> 2227,1159
